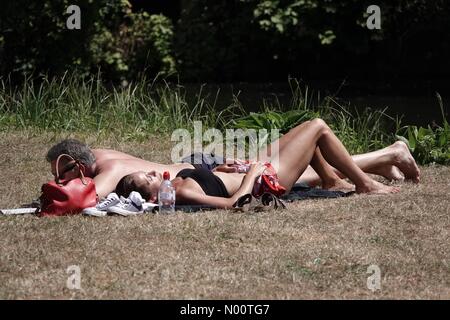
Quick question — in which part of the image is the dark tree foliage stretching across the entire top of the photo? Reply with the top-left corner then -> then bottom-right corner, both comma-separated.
0,0 -> 450,81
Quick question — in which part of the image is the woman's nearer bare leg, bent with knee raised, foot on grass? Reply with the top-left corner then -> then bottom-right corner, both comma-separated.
271,119 -> 398,193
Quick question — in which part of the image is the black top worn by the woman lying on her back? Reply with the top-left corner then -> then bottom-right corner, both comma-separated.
177,169 -> 230,198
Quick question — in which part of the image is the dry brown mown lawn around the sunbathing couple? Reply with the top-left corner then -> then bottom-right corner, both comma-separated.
0,132 -> 450,299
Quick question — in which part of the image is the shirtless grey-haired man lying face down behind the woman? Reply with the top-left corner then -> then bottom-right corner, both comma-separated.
46,120 -> 420,199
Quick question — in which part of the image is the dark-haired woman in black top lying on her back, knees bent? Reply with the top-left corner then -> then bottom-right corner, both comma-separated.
116,119 -> 410,208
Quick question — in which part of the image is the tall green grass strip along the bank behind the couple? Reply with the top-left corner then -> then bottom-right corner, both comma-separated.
0,74 -> 450,164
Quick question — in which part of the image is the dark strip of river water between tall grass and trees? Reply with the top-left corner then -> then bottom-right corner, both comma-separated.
186,82 -> 450,126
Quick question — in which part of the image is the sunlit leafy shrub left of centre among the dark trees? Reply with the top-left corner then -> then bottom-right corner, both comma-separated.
90,10 -> 175,80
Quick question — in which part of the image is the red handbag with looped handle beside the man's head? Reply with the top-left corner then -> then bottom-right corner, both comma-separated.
38,154 -> 97,216
